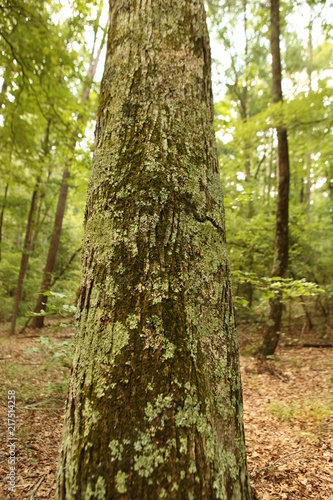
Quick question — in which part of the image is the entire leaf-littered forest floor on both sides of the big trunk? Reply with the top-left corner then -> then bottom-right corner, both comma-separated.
0,325 -> 333,500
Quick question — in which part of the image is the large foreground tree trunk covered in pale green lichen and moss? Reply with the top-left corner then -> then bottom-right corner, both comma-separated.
56,0 -> 250,500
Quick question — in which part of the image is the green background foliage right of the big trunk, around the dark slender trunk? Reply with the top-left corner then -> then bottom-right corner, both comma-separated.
210,0 -> 332,344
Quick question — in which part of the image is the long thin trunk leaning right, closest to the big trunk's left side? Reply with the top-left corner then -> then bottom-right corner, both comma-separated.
31,19 -> 106,328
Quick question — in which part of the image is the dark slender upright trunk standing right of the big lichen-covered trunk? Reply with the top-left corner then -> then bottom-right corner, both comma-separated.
261,0 -> 289,355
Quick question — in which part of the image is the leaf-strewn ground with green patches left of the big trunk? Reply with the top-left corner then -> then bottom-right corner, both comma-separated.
0,322 -> 73,499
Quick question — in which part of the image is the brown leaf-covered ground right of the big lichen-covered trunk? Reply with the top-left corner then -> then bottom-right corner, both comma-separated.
241,348 -> 333,500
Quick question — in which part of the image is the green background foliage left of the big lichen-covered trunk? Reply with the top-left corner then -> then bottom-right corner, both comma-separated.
0,0 -> 105,320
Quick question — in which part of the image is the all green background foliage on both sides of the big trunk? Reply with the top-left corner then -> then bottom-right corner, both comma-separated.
0,0 -> 333,336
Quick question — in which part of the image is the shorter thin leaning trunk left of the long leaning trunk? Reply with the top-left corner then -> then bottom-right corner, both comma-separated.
10,177 -> 40,335
